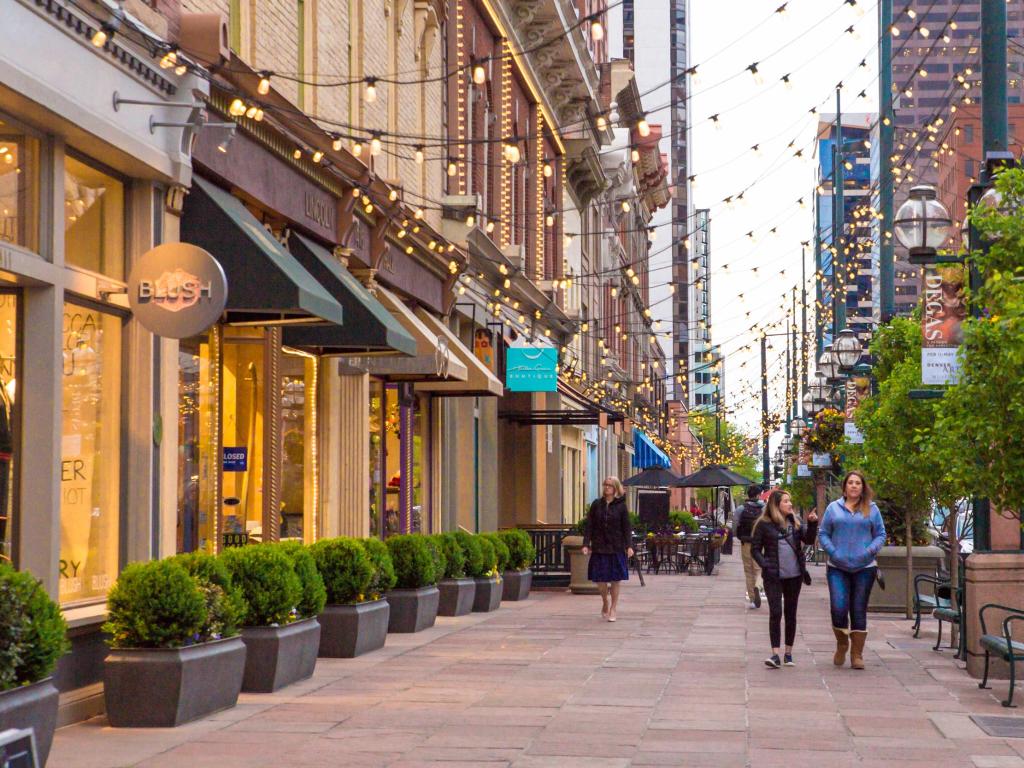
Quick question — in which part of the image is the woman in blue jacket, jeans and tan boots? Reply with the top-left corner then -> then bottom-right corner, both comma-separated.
818,472 -> 886,670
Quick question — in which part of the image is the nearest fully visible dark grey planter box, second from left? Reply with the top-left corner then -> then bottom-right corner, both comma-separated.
103,637 -> 246,728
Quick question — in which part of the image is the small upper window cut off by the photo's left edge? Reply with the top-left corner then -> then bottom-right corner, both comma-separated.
0,118 -> 39,251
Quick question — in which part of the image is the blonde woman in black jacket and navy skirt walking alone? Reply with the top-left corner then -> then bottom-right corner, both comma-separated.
583,477 -> 633,622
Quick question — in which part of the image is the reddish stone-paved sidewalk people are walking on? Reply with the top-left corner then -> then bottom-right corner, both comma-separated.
49,556 -> 1024,768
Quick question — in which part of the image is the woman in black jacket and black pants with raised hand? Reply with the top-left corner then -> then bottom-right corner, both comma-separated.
751,490 -> 818,670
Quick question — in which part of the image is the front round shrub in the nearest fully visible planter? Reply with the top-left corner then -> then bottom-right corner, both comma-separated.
103,559 -> 207,648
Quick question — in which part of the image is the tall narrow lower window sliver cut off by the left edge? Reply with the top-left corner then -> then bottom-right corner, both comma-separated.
0,293 -> 17,562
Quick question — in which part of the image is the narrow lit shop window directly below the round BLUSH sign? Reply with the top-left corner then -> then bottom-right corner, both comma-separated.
177,338 -> 218,553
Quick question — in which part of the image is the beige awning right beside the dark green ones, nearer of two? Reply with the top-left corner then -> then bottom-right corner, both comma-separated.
347,286 -> 469,382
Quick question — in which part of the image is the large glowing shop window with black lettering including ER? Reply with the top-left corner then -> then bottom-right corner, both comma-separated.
59,303 -> 122,604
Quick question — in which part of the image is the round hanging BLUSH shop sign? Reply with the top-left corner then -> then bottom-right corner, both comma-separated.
128,243 -> 227,339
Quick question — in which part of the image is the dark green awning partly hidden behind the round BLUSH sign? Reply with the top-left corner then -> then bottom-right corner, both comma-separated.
181,176 -> 345,326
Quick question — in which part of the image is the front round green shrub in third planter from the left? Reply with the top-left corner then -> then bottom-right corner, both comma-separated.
220,544 -> 302,627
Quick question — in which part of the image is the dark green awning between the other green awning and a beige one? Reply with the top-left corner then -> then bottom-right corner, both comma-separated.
284,231 -> 416,355
